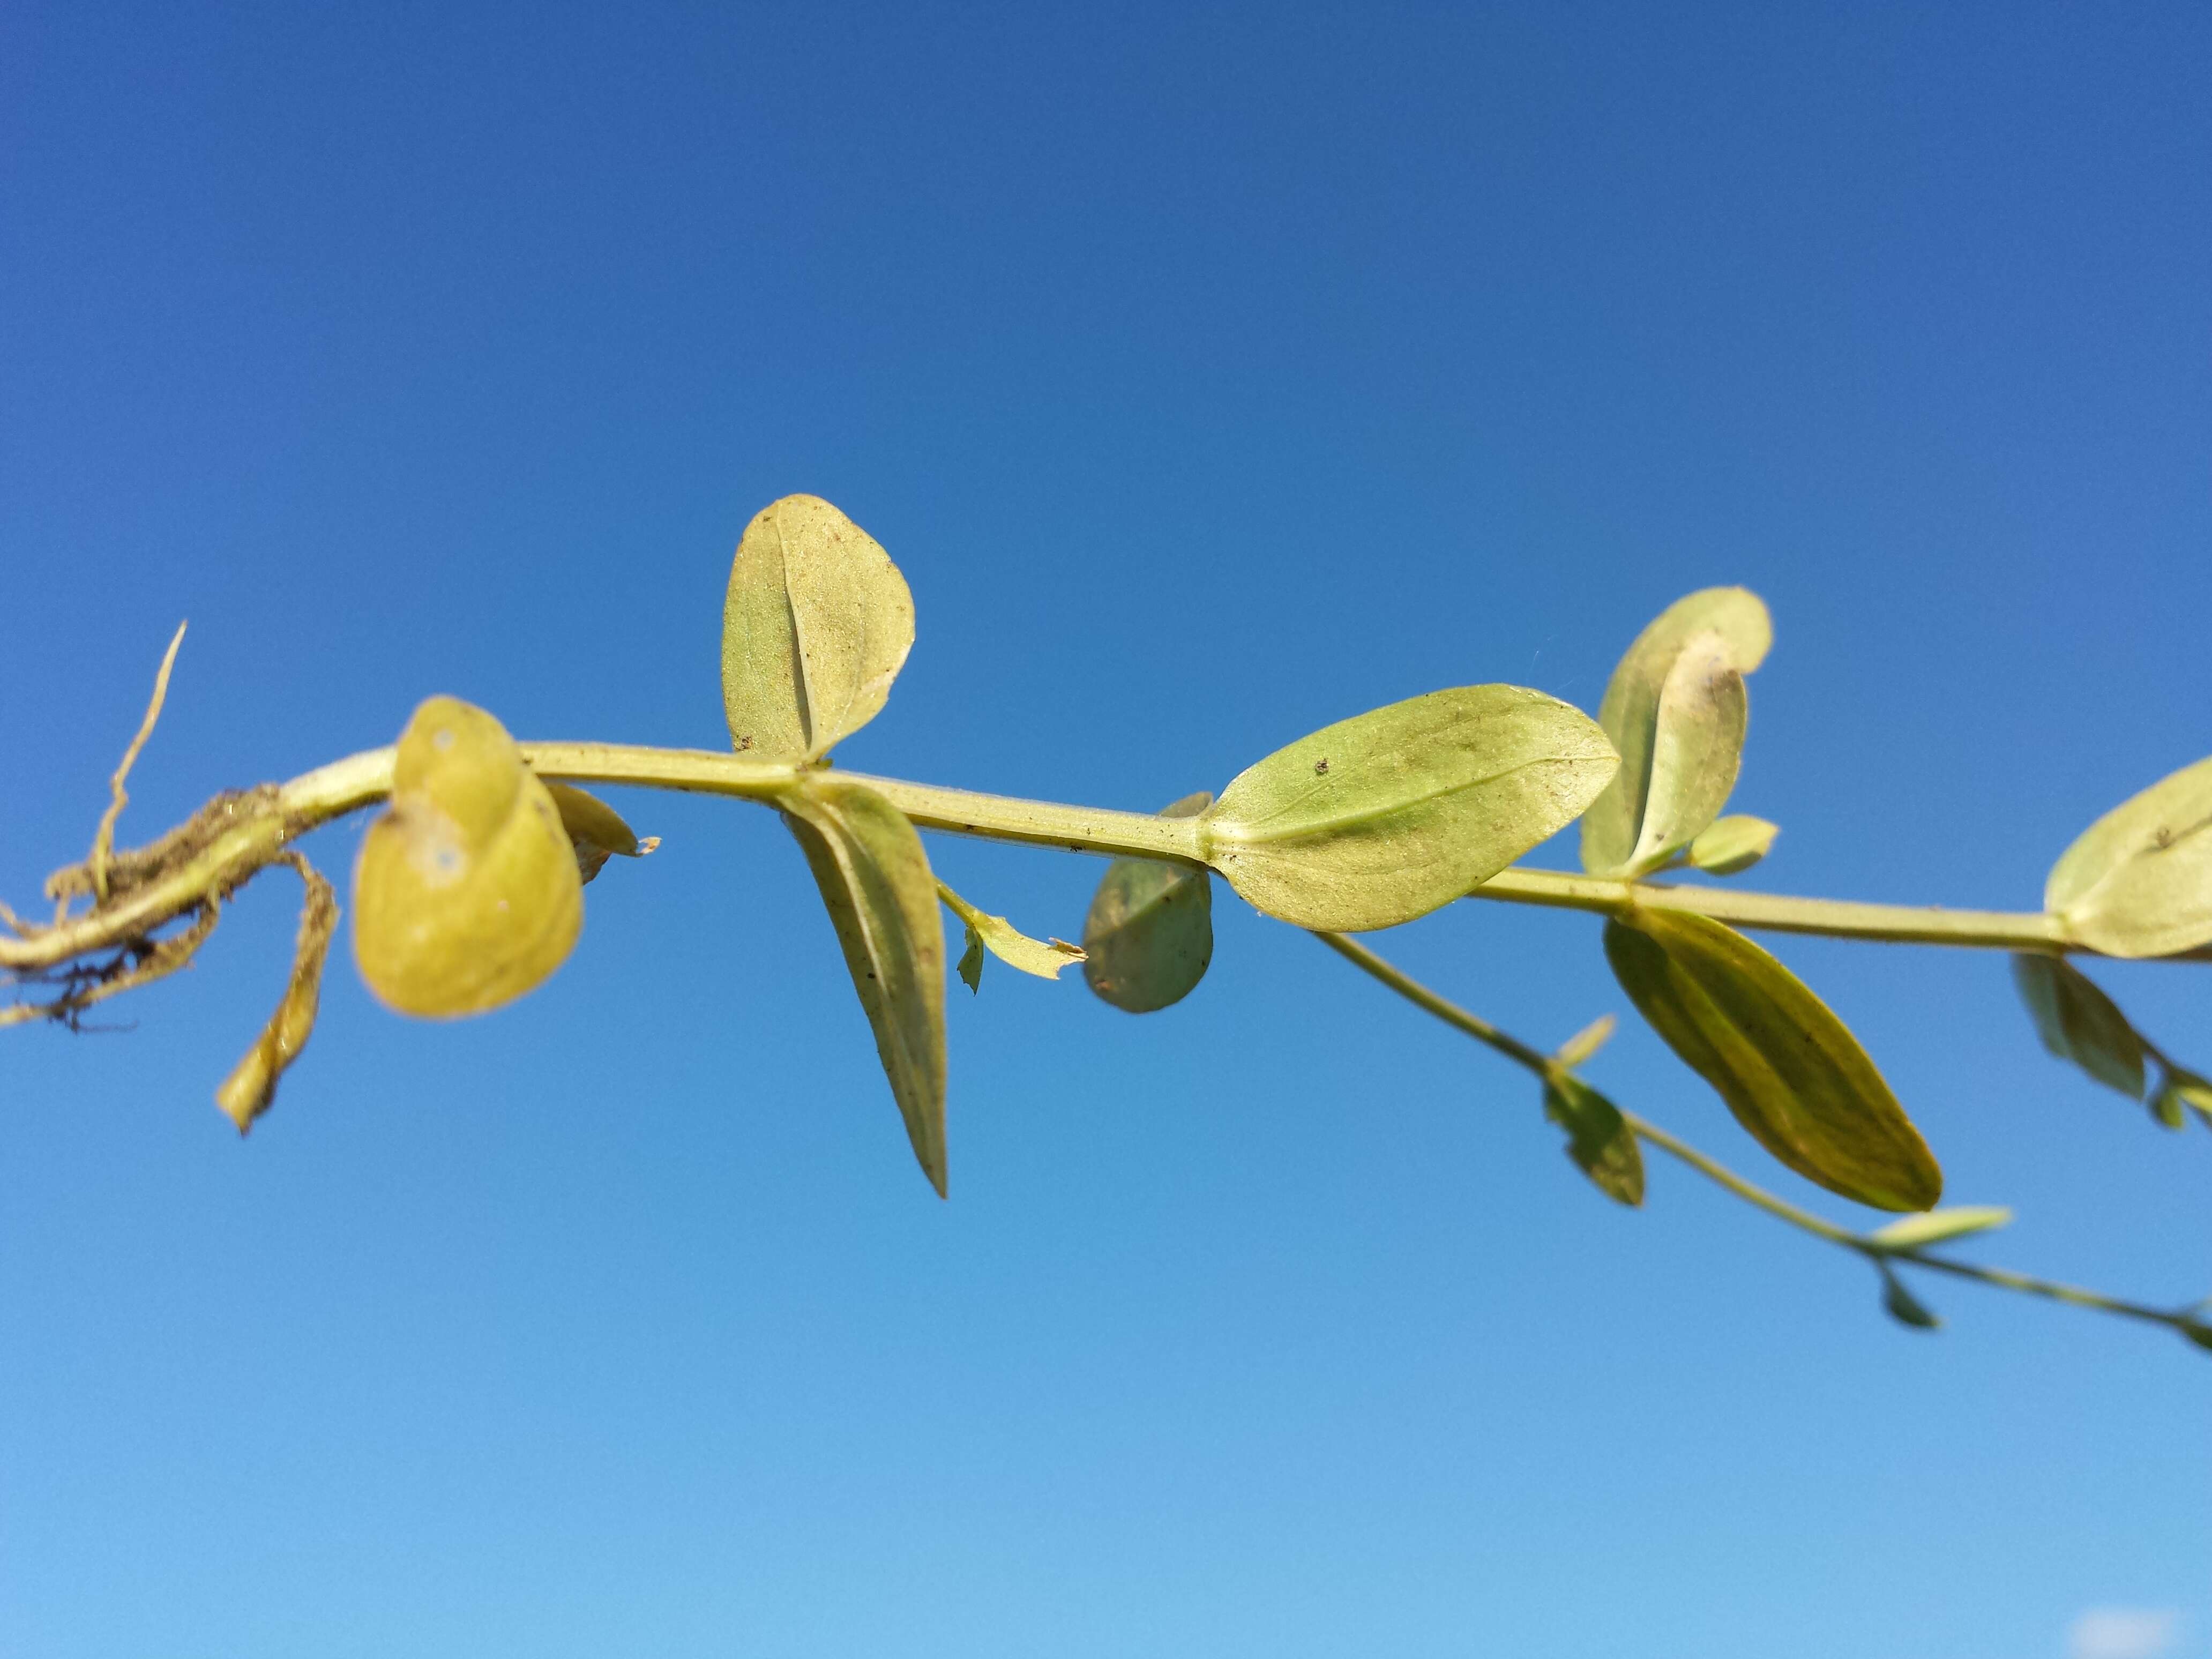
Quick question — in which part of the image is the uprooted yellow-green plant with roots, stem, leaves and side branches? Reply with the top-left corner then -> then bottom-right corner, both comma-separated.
0,496 -> 2212,1349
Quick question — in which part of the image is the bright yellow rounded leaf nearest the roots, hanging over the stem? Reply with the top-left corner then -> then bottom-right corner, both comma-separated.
354,697 -> 584,1018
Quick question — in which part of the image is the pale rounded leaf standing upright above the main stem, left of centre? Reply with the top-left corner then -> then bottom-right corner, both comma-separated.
721,496 -> 914,761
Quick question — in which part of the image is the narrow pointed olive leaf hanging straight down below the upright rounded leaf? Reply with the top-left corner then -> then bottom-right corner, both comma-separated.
781,772 -> 945,1197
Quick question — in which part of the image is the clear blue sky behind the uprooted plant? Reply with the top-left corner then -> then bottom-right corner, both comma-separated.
0,2 -> 2212,1659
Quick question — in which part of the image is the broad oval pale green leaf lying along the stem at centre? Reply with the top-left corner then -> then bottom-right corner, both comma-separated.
1201,686 -> 1615,933
